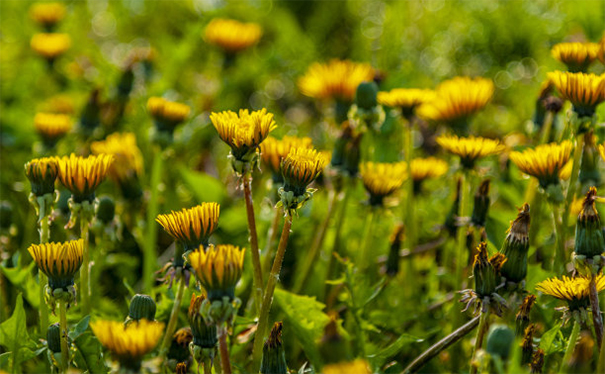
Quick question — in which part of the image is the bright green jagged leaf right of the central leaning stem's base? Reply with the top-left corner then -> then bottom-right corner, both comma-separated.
274,289 -> 330,367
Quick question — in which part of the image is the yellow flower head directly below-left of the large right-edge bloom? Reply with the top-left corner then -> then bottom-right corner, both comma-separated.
509,140 -> 572,189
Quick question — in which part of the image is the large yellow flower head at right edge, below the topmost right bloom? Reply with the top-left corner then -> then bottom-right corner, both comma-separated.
548,71 -> 605,117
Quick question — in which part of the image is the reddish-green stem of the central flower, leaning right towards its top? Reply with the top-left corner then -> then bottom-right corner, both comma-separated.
253,214 -> 292,368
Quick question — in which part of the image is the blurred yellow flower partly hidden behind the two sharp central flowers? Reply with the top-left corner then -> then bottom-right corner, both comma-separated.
260,135 -> 313,182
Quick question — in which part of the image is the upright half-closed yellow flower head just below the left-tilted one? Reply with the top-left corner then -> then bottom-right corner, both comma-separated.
187,244 -> 244,301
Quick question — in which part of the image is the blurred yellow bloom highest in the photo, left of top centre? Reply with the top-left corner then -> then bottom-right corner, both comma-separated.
204,18 -> 263,53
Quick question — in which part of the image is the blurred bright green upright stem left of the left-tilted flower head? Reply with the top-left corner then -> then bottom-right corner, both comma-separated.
143,146 -> 163,293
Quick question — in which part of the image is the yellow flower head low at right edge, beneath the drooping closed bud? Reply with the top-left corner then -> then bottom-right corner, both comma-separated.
536,274 -> 605,311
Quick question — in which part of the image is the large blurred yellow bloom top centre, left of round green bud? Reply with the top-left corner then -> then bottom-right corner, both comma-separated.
298,60 -> 374,103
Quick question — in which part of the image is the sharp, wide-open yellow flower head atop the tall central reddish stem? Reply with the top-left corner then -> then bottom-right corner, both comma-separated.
210,108 -> 277,162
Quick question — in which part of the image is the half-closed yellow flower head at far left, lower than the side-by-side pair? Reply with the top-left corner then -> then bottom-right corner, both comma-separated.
27,239 -> 84,290
